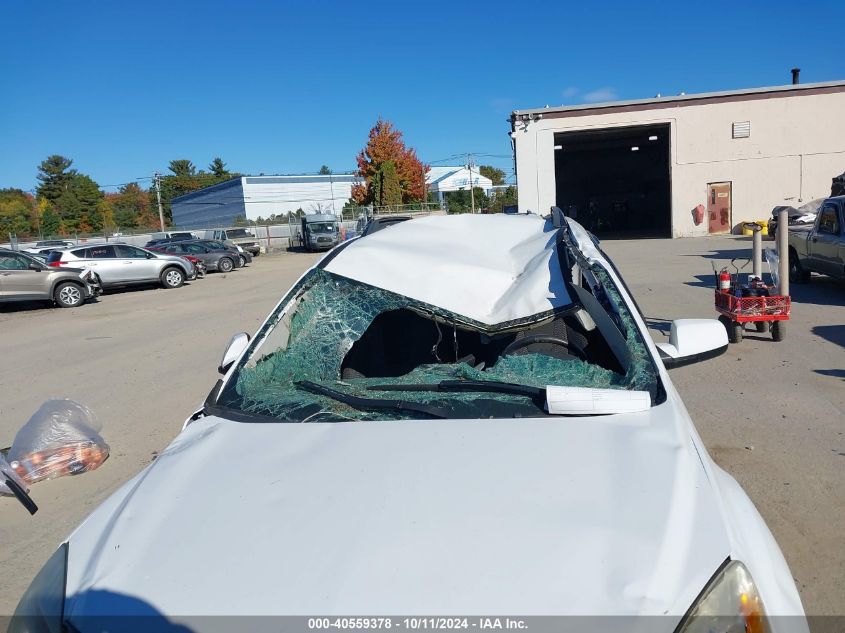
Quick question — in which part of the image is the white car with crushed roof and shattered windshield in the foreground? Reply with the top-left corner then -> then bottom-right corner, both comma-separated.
12,213 -> 807,633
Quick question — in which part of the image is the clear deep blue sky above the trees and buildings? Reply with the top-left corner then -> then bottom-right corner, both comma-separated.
0,0 -> 845,189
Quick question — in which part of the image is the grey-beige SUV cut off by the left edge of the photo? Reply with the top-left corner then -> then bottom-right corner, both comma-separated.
0,249 -> 100,308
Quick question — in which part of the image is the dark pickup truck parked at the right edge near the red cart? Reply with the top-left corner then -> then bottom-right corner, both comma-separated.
789,196 -> 845,282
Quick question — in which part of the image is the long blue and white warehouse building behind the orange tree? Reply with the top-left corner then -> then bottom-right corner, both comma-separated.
171,174 -> 359,228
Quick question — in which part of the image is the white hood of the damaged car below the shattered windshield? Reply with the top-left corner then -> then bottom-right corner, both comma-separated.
65,401 -> 730,630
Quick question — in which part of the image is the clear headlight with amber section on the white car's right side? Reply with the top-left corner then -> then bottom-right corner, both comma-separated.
678,561 -> 769,633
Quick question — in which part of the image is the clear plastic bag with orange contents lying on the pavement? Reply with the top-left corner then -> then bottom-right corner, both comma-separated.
6,400 -> 109,485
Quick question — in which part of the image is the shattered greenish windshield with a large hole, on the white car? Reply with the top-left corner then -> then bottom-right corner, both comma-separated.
216,260 -> 656,422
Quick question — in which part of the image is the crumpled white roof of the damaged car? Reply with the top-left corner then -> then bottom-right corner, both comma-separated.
325,215 -> 572,325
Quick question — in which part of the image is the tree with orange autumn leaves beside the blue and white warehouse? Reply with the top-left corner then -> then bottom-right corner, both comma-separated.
352,117 -> 429,205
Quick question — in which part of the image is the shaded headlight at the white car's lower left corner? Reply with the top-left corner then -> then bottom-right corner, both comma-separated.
8,543 -> 68,633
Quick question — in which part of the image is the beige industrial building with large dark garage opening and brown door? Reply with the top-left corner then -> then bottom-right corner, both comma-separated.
511,81 -> 845,237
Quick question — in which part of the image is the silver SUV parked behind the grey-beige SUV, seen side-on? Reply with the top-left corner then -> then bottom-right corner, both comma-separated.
47,243 -> 197,288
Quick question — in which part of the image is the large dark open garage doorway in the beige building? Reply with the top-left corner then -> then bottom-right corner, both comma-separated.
555,124 -> 672,238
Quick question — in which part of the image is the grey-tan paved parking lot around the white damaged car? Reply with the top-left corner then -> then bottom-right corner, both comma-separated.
0,238 -> 845,614
